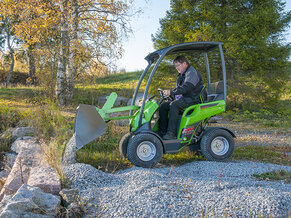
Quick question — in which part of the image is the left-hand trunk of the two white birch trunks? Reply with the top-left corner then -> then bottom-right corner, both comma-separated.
56,0 -> 69,105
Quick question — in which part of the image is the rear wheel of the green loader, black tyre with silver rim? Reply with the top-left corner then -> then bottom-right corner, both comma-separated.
200,128 -> 235,161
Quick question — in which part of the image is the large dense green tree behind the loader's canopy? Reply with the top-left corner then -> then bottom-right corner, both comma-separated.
153,0 -> 291,107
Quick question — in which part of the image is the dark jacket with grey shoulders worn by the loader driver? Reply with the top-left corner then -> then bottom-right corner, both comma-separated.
171,65 -> 203,103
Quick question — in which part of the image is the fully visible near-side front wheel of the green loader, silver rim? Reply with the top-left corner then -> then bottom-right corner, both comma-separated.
127,133 -> 163,168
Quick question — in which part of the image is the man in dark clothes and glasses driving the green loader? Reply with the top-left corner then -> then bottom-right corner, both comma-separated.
158,56 -> 207,140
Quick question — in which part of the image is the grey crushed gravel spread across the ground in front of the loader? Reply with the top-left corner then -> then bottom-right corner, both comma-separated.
64,161 -> 291,217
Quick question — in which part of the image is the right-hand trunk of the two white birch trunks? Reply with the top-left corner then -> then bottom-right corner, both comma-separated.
67,0 -> 79,101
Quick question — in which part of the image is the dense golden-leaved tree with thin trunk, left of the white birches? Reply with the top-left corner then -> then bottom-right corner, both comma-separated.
0,0 -> 58,86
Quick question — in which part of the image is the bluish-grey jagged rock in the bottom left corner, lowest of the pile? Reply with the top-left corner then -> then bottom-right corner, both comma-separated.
0,184 -> 60,218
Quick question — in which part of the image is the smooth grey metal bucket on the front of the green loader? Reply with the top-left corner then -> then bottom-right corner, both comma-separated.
74,104 -> 107,150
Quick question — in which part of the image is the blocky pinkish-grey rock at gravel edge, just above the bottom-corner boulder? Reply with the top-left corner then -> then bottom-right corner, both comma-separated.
27,167 -> 61,195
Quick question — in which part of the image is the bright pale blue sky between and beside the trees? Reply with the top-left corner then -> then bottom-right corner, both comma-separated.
118,0 -> 291,72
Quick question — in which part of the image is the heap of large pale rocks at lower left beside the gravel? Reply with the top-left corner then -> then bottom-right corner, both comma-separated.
0,127 -> 61,217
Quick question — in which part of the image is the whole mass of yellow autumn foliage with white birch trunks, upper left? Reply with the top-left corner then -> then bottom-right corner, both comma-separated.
0,0 -> 131,104
